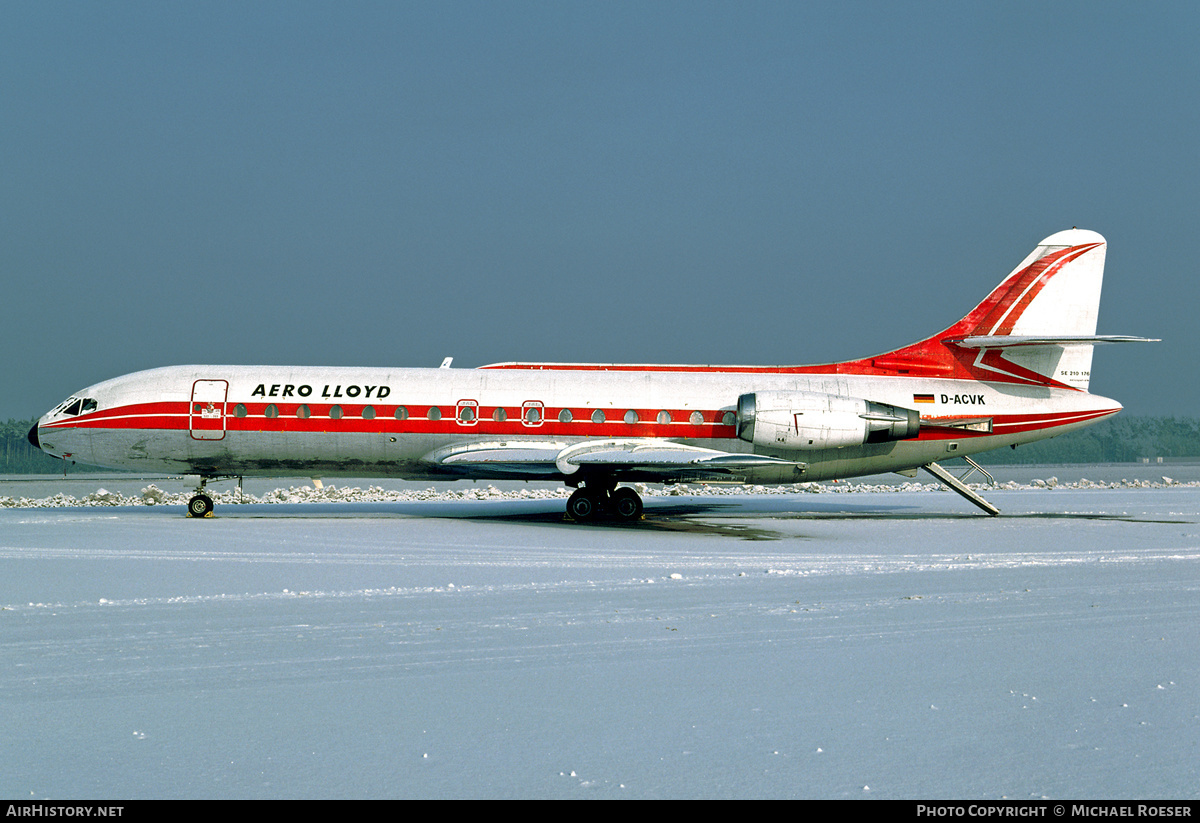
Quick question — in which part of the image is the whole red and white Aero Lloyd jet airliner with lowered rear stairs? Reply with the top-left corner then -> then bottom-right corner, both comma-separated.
29,229 -> 1145,522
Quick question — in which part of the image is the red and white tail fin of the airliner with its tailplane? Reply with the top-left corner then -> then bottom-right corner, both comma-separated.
846,229 -> 1142,391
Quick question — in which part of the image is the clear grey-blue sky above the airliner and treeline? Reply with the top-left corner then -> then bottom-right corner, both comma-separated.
0,1 -> 1200,419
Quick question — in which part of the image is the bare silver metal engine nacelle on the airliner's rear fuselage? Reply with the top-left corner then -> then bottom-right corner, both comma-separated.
738,391 -> 920,451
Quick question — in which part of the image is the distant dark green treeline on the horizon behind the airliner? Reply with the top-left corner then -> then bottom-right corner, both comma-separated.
0,415 -> 1200,474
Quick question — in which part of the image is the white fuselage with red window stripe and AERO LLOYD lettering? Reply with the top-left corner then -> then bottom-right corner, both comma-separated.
30,366 -> 1121,483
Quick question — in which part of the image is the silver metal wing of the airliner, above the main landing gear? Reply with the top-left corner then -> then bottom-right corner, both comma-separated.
424,439 -> 805,479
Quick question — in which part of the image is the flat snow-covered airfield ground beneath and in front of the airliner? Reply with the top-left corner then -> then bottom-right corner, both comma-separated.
0,465 -> 1200,800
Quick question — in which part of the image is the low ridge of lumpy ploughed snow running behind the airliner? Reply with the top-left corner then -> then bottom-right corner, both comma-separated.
0,476 -> 1200,509
